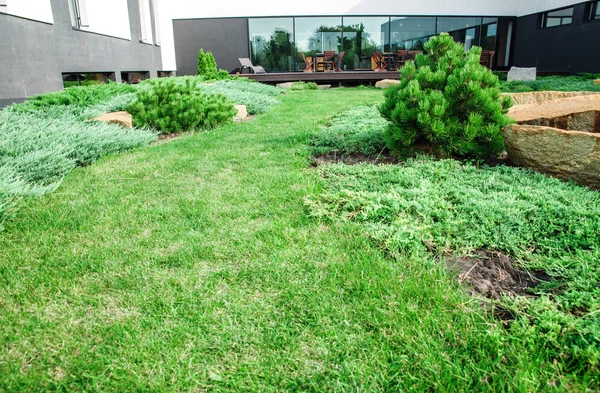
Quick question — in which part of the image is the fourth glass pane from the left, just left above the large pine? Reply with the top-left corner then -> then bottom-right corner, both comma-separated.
386,17 -> 435,52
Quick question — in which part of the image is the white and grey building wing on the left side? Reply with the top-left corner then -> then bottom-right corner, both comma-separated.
0,0 -> 162,107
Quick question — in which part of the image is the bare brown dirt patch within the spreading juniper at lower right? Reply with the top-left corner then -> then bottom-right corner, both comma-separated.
446,251 -> 552,300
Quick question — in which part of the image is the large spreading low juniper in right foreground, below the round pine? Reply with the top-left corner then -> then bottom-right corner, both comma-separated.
306,158 -> 600,375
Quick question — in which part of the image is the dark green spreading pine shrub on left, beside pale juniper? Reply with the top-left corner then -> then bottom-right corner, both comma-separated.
127,78 -> 236,134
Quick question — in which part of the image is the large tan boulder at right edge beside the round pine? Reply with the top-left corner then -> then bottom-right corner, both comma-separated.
502,124 -> 600,189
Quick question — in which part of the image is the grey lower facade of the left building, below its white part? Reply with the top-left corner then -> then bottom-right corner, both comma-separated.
0,0 -> 162,106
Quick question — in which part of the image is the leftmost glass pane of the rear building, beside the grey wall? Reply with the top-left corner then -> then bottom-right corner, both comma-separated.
248,18 -> 295,72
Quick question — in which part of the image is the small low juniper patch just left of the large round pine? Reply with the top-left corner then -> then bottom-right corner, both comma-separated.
310,106 -> 387,155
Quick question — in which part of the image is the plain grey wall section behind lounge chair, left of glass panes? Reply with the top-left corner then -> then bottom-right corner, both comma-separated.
173,18 -> 250,75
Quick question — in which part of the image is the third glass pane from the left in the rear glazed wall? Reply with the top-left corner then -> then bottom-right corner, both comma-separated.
340,17 -> 390,70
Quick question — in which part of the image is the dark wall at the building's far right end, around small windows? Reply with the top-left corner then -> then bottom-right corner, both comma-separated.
513,3 -> 600,73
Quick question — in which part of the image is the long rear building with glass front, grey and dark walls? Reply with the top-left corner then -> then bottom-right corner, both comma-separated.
173,0 -> 600,75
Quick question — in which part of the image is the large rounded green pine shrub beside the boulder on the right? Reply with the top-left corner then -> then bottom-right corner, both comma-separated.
379,33 -> 512,158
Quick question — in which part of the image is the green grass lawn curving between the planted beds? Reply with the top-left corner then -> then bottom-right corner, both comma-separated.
0,89 -> 598,392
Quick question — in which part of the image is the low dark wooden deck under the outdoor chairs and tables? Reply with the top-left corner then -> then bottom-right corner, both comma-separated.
239,71 -> 400,86
